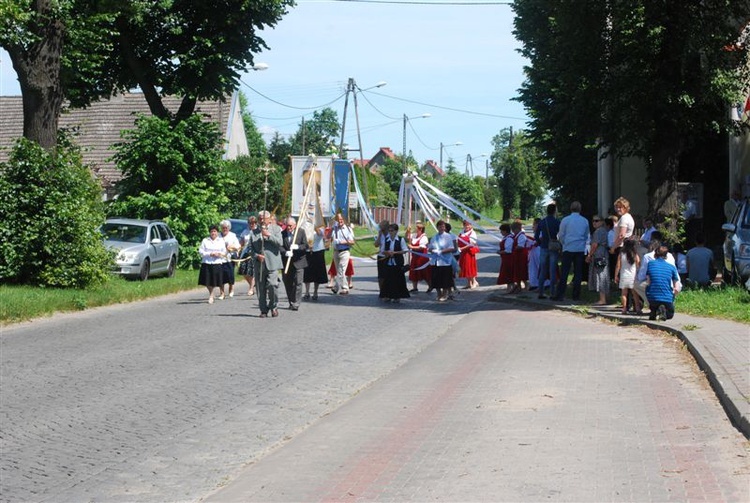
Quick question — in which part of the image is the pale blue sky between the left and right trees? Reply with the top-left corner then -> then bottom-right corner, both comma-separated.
0,0 -> 528,175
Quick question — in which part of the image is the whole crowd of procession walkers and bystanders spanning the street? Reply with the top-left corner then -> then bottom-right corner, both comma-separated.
198,198 -> 712,319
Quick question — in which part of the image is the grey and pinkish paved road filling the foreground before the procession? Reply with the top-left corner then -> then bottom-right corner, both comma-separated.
0,257 -> 750,502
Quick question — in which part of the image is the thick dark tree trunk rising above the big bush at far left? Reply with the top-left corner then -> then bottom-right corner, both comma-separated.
7,0 -> 65,150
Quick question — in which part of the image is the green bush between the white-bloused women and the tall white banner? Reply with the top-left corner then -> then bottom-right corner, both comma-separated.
221,156 -> 287,217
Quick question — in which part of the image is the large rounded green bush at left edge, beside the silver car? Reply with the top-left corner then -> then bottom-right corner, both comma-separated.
0,139 -> 113,288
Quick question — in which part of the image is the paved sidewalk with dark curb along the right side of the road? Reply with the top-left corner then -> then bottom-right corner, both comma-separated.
508,293 -> 750,439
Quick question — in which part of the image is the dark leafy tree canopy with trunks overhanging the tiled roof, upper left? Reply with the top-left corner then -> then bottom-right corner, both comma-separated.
0,0 -> 293,148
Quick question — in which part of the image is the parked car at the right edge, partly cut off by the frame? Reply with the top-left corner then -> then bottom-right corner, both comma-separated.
721,198 -> 750,285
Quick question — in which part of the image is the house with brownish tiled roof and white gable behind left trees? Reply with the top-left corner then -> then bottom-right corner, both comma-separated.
0,92 -> 248,199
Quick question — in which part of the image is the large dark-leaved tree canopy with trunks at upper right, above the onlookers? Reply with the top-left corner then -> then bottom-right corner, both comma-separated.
514,0 -> 750,226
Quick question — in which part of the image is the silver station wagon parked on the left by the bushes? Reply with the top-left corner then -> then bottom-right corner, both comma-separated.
100,218 -> 180,281
